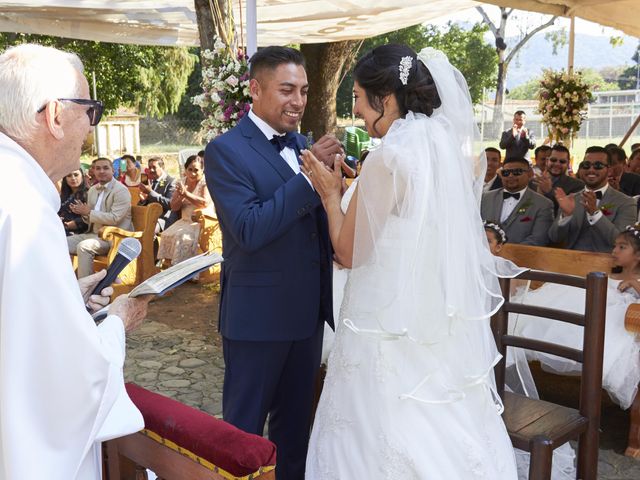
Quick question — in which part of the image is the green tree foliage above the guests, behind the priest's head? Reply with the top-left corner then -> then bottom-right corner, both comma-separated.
0,33 -> 197,117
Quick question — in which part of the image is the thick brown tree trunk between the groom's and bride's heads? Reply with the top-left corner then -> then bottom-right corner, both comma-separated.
300,40 -> 358,140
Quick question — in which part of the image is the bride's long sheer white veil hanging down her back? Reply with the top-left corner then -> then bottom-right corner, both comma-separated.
344,49 -> 522,402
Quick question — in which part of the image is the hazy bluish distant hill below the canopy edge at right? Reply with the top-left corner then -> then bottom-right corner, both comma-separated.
502,30 -> 638,88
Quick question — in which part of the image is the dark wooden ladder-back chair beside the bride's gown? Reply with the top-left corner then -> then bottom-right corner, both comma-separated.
491,270 -> 607,480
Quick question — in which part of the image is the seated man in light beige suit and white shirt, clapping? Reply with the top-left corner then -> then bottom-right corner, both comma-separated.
67,157 -> 133,278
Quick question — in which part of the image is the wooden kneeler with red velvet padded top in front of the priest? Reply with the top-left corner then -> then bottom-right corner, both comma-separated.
103,384 -> 276,480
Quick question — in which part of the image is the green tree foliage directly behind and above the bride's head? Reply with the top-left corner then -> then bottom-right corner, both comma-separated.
337,23 -> 498,117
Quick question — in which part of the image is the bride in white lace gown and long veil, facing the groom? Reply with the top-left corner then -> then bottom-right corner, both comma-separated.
302,45 -> 517,480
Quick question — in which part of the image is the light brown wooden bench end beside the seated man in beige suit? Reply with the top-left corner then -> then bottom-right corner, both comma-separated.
93,203 -> 162,298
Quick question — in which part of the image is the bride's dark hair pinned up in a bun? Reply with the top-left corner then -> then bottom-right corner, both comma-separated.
353,44 -> 441,135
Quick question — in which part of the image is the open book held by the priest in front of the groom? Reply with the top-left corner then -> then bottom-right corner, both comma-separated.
92,252 -> 223,323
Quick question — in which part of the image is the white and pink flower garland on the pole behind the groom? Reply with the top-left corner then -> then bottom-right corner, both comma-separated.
191,38 -> 251,142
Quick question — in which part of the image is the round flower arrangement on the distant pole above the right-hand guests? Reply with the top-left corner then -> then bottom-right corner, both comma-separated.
538,70 -> 592,143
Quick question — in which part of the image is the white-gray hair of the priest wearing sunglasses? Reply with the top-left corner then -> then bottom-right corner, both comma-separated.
0,44 -> 84,140
